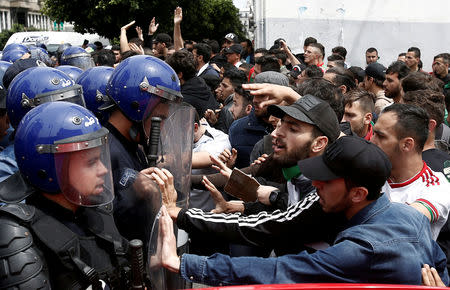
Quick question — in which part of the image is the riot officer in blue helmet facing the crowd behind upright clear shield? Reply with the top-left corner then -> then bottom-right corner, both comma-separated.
104,56 -> 181,241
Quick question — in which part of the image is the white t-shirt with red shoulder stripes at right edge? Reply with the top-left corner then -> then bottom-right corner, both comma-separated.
382,162 -> 450,240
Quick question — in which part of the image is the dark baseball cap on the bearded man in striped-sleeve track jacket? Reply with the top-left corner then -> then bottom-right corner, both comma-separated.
267,95 -> 341,143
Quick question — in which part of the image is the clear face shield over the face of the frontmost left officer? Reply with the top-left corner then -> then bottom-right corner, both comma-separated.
50,128 -> 114,206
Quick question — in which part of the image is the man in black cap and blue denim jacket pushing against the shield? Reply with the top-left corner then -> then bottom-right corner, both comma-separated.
160,136 -> 448,285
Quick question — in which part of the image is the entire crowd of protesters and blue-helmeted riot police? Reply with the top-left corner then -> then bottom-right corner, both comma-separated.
0,7 -> 450,289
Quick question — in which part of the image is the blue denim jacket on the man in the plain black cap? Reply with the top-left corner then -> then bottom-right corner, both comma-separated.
180,195 -> 449,285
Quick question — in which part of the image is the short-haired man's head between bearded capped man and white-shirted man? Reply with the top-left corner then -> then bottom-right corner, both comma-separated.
342,89 -> 375,140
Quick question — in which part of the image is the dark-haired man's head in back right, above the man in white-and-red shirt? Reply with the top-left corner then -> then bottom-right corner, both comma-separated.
383,61 -> 411,103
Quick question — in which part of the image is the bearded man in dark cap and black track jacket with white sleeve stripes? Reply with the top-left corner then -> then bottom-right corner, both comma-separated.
151,95 -> 342,254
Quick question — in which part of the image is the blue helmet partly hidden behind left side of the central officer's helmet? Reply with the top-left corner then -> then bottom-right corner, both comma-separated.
76,66 -> 114,122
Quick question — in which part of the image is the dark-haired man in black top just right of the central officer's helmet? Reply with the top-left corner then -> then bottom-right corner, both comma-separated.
167,50 -> 219,117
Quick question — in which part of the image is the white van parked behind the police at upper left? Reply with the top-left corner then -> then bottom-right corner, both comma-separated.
5,31 -> 110,52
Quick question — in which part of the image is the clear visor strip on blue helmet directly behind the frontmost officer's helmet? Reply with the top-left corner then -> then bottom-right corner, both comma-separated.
21,85 -> 86,108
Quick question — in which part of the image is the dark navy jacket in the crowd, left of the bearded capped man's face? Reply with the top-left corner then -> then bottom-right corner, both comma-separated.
228,110 -> 268,168
